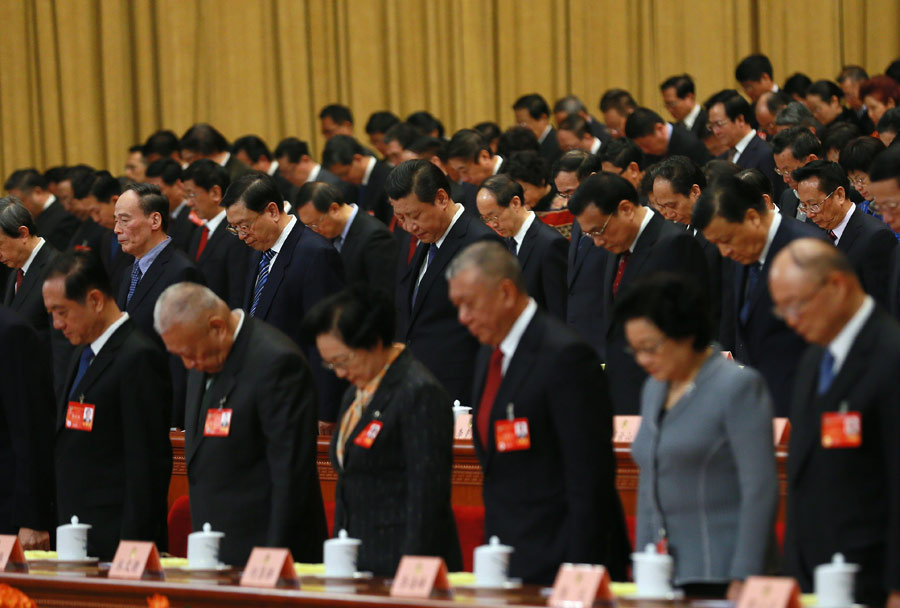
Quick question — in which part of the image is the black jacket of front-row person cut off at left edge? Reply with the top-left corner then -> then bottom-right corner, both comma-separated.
0,306 -> 56,534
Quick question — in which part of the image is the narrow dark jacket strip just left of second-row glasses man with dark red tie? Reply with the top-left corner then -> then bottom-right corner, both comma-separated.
566,220 -> 610,361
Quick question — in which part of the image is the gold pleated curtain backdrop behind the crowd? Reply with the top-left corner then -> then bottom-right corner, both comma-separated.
0,0 -> 900,176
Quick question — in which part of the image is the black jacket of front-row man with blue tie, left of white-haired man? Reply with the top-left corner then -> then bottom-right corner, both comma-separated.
55,319 -> 172,560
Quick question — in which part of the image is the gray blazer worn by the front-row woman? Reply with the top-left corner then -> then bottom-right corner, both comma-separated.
631,348 -> 778,585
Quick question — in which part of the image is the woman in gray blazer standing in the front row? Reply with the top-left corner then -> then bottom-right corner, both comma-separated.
616,274 -> 778,599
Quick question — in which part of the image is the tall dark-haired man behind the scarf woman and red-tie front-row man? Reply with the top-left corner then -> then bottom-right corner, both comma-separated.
387,160 -> 502,401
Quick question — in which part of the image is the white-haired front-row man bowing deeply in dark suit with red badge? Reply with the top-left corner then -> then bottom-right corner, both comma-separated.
156,283 -> 327,566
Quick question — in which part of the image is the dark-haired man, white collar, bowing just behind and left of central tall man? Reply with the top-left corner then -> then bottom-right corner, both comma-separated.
322,135 -> 393,226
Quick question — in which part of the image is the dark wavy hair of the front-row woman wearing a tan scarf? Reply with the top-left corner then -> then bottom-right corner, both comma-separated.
300,283 -> 394,350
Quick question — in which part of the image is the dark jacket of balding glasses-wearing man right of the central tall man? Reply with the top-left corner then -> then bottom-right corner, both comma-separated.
516,216 -> 569,321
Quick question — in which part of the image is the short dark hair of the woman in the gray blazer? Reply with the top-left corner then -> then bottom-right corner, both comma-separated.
613,272 -> 718,350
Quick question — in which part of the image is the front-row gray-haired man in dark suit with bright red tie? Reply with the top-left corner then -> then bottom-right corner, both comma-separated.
447,242 -> 629,585
